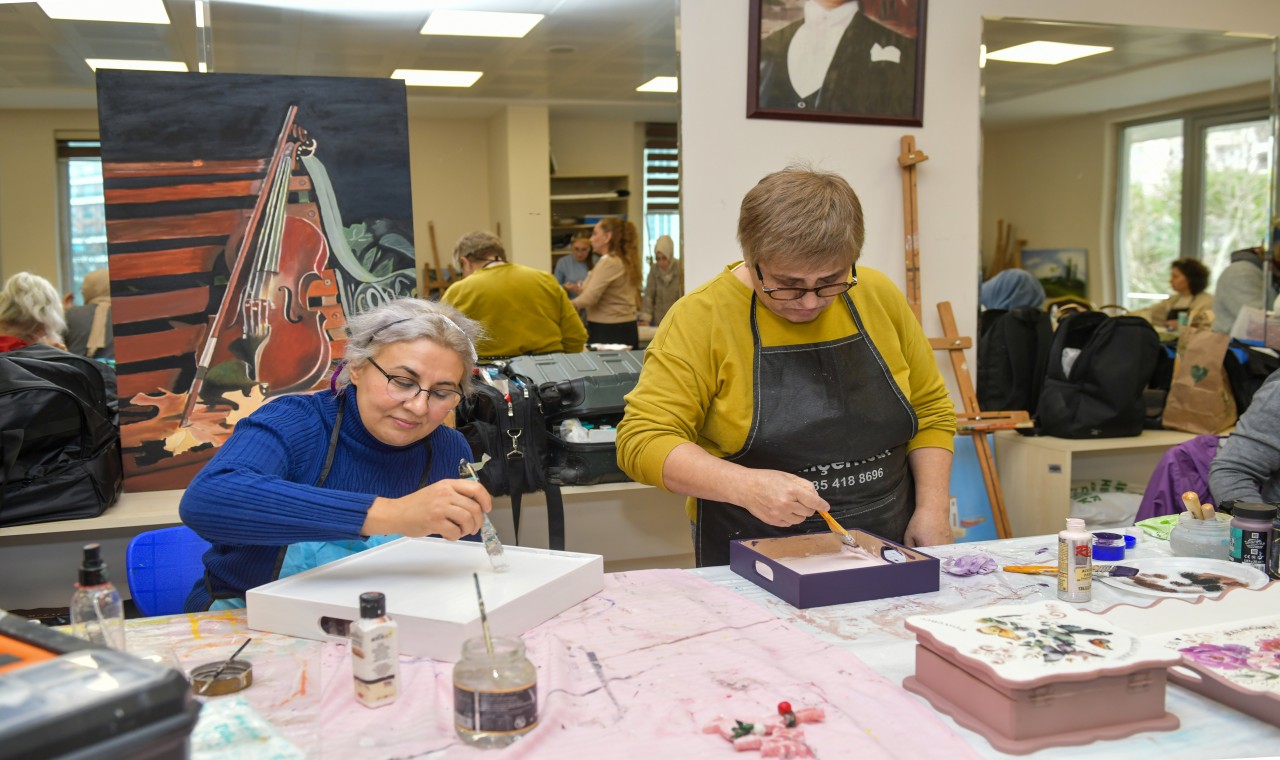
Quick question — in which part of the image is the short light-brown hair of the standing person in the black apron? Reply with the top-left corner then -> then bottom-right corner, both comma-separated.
737,164 -> 867,267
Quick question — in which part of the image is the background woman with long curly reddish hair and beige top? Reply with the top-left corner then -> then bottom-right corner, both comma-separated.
573,216 -> 640,348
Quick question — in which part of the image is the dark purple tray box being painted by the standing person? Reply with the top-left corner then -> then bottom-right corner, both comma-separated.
728,530 -> 940,609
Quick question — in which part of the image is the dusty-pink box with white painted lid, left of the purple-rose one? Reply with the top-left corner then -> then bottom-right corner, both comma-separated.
902,601 -> 1180,755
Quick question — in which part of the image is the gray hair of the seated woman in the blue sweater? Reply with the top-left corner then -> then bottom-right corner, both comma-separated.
334,298 -> 484,395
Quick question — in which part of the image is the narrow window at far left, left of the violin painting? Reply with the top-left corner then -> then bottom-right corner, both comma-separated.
58,141 -> 106,303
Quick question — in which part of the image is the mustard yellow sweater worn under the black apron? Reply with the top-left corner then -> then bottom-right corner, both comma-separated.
617,266 -> 956,518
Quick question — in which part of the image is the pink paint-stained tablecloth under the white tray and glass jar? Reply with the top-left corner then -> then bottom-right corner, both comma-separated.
129,571 -> 975,760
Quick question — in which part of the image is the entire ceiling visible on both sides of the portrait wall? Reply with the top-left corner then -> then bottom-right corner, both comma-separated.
0,0 -> 1274,127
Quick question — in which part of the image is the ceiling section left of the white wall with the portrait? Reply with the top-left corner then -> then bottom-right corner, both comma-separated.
0,0 -> 678,120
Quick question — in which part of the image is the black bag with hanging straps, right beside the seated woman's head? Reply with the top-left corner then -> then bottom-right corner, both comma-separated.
457,375 -> 564,550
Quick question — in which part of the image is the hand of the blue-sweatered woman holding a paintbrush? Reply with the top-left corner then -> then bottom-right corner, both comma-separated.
360,480 -> 493,541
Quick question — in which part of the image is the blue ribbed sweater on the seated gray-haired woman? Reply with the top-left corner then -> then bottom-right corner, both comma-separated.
180,386 -> 471,612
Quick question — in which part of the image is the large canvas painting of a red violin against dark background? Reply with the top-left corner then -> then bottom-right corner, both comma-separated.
97,70 -> 417,491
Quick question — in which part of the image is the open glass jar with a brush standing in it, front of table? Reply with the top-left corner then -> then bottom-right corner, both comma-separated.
453,636 -> 538,747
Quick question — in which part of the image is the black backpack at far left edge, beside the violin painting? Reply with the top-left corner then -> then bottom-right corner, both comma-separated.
0,345 -> 124,527
